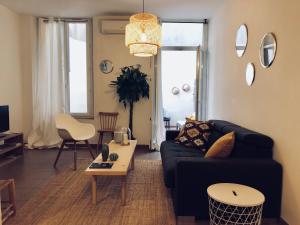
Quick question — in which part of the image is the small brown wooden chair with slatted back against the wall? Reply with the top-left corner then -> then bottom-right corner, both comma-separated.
97,112 -> 119,153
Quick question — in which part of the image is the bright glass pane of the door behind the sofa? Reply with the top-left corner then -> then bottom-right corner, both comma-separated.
161,48 -> 199,129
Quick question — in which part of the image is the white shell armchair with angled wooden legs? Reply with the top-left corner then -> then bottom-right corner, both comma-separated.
53,113 -> 96,170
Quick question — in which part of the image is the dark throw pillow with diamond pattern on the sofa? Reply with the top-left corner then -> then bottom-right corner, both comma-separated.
175,120 -> 212,151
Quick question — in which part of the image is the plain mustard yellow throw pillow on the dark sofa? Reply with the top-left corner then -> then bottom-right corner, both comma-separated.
204,132 -> 235,158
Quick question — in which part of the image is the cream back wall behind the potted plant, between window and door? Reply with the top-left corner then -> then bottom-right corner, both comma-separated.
84,17 -> 153,145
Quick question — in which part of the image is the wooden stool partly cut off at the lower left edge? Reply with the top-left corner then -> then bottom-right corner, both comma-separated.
0,179 -> 17,224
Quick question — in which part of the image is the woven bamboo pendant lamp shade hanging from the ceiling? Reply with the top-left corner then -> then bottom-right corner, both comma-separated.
125,13 -> 161,57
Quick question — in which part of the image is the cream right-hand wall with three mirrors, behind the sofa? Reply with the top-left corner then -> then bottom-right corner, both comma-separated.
209,0 -> 300,225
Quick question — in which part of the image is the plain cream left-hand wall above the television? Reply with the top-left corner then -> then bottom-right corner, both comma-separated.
0,5 -> 34,139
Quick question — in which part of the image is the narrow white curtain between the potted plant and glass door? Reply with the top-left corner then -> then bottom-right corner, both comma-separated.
152,54 -> 166,150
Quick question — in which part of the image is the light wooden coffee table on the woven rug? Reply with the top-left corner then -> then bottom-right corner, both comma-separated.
85,140 -> 137,205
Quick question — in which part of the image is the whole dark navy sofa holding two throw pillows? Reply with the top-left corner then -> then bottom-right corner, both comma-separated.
160,120 -> 282,219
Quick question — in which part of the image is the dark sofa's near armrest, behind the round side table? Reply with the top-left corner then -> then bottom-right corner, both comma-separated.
173,157 -> 282,218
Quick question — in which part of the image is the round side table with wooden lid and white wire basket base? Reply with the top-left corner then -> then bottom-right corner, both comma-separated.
207,183 -> 265,225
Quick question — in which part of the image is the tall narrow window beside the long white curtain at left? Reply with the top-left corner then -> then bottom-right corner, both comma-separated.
65,20 -> 93,118
